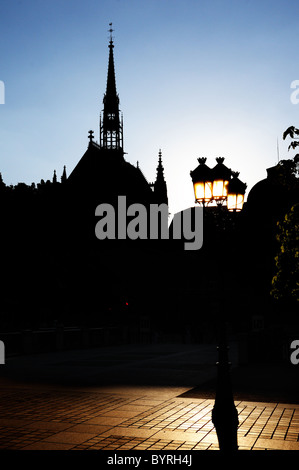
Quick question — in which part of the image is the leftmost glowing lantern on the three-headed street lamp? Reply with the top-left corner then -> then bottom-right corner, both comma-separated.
190,158 -> 213,204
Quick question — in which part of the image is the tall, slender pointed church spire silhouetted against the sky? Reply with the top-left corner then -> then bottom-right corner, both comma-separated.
100,23 -> 123,156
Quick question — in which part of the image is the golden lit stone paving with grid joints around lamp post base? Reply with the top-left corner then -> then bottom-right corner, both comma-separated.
0,388 -> 299,451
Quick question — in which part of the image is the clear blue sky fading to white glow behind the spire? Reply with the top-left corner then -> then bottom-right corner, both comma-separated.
0,0 -> 299,213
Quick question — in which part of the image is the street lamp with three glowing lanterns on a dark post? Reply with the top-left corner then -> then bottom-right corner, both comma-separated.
190,157 -> 246,451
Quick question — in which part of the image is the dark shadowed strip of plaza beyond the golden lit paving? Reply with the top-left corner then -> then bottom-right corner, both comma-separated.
0,344 -> 299,404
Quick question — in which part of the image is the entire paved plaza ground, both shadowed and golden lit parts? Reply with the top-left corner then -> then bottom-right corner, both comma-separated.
0,345 -> 299,451
